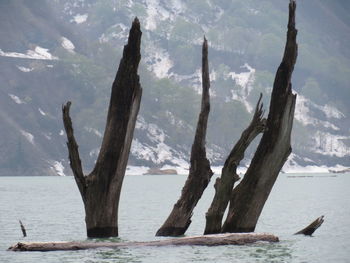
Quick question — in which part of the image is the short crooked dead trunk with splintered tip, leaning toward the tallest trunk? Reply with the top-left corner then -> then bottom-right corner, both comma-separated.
204,94 -> 266,235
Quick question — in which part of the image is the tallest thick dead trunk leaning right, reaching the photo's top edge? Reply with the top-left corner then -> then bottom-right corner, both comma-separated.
222,0 -> 297,233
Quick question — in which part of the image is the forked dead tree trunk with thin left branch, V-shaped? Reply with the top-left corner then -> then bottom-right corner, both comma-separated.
62,18 -> 142,237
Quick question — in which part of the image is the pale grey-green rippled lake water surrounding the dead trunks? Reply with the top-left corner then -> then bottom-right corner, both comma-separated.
0,174 -> 350,263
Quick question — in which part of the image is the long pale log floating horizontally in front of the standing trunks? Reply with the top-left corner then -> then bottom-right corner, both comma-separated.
8,233 -> 279,251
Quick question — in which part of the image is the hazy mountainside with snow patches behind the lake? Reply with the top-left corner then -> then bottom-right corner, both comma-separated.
0,0 -> 350,175
